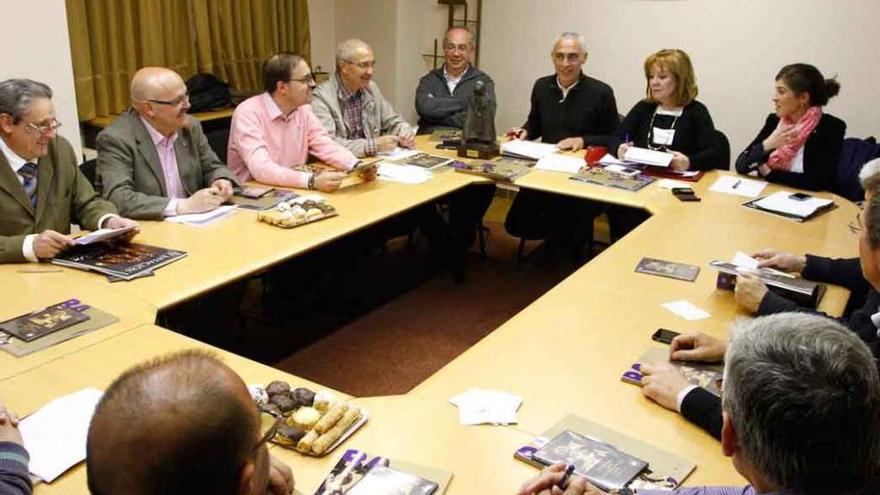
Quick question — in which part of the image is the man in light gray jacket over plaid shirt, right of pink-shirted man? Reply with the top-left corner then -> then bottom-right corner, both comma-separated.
312,39 -> 415,157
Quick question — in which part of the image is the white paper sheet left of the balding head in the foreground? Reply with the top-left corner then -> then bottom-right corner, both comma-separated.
18,388 -> 104,483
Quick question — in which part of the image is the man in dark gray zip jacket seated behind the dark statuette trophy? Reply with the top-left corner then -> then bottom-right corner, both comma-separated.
416,26 -> 495,134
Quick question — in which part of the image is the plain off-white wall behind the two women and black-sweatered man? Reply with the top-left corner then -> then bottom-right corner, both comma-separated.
481,0 -> 880,168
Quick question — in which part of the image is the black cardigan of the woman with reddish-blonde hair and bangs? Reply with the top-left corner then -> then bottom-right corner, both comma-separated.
609,100 -> 730,170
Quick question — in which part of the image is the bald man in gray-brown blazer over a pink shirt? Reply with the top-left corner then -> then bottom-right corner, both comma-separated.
97,67 -> 238,220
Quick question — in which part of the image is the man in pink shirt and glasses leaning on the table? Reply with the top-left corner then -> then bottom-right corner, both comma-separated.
227,53 -> 376,192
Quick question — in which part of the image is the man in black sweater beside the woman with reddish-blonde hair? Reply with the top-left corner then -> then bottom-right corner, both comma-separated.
505,33 -> 620,258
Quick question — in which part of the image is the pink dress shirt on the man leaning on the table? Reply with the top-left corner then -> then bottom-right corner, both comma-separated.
227,93 -> 358,187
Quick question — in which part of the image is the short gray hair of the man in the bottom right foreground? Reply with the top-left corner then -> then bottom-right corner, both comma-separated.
723,313 -> 880,495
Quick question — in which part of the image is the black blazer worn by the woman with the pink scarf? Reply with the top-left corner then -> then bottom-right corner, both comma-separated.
736,113 -> 846,191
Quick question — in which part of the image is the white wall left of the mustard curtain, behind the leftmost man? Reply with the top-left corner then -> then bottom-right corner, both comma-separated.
0,0 -> 82,157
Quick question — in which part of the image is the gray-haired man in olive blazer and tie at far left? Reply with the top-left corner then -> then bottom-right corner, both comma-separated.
0,79 -> 137,263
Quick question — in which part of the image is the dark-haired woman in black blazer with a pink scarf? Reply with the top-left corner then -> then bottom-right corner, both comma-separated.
736,64 -> 846,191
